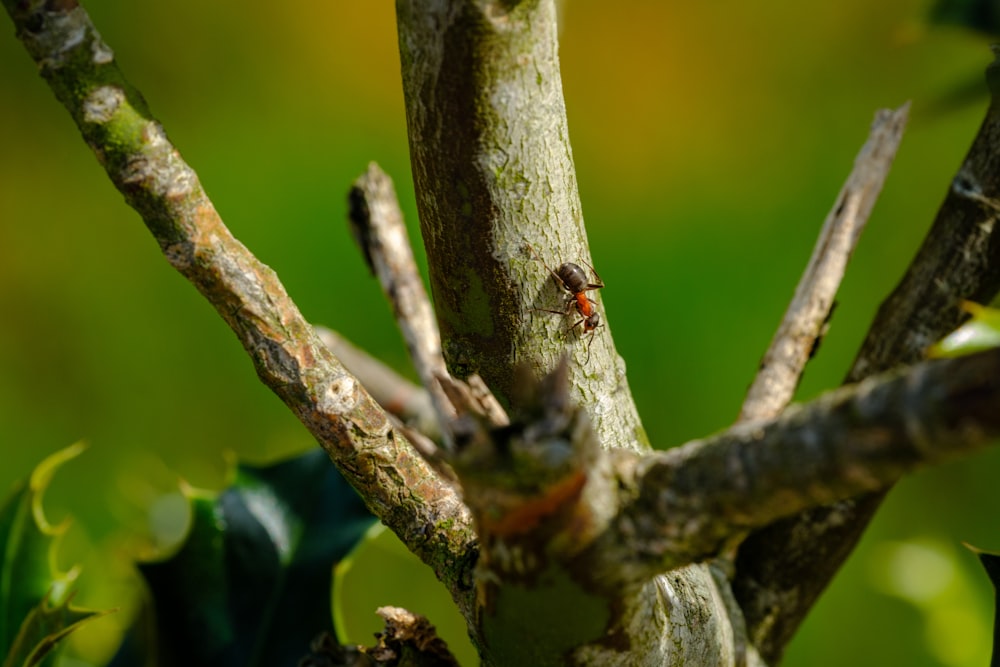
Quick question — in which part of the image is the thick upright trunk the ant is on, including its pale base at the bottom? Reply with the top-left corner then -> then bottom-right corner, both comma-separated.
396,0 -> 756,665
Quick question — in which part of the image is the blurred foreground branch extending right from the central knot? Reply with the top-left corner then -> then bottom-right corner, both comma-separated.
589,348 -> 1000,590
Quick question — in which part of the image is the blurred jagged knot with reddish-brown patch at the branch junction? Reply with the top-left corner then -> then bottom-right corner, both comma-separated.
441,358 -> 601,574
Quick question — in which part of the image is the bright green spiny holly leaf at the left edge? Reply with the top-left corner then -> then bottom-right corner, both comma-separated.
0,443 -> 114,667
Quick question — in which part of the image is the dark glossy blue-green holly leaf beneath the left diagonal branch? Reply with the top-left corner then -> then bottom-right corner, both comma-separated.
112,449 -> 375,667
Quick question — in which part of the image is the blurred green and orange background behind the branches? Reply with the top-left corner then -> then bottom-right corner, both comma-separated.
0,0 -> 1000,667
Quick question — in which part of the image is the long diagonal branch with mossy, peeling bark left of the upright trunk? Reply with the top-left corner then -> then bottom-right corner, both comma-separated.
3,0 -> 476,615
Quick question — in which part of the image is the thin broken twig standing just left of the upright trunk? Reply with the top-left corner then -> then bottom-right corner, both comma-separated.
349,162 -> 455,448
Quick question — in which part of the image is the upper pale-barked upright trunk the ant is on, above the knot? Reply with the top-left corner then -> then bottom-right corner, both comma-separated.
396,0 -> 648,448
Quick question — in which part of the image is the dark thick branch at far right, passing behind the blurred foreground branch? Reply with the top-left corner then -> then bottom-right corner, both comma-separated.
733,56 -> 1000,662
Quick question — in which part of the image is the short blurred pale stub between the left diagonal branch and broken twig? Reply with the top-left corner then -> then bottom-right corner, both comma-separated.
314,326 -> 441,441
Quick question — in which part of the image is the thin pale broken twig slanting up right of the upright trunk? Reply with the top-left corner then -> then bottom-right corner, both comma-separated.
739,104 -> 909,421
